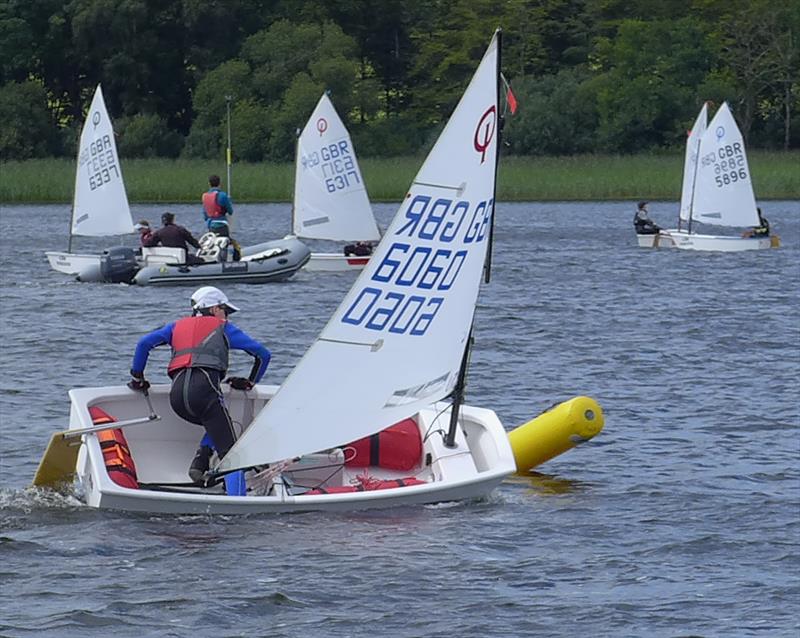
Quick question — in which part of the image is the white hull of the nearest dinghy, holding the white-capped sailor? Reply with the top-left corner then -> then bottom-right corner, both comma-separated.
69,385 -> 516,514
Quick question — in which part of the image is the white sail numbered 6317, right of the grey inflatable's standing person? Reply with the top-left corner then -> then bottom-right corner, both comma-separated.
292,94 -> 380,241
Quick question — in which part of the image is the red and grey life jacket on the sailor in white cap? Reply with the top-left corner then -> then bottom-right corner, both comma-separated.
167,316 -> 228,377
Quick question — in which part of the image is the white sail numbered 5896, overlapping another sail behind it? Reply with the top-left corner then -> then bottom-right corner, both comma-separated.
692,102 -> 759,226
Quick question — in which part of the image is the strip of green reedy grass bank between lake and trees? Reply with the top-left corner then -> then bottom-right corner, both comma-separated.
0,151 -> 800,204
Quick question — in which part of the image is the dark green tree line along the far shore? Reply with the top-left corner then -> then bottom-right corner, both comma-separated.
0,0 -> 800,162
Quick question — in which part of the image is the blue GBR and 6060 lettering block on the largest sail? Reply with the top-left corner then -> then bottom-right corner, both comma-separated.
341,195 -> 493,335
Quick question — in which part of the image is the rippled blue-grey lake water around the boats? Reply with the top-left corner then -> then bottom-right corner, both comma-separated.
0,201 -> 800,638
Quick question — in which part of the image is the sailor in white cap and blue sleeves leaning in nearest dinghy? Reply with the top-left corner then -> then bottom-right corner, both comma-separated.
128,286 -> 271,495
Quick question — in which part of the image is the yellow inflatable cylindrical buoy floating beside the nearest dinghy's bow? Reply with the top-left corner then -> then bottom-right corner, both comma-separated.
508,397 -> 604,474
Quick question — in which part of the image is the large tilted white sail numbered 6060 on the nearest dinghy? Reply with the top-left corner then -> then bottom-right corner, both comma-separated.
220,34 -> 499,470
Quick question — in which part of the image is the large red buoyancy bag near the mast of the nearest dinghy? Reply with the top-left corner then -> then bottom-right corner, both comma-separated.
345,419 -> 422,470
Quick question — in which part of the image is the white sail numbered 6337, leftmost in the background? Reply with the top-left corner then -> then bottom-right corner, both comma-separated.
71,84 -> 133,237
